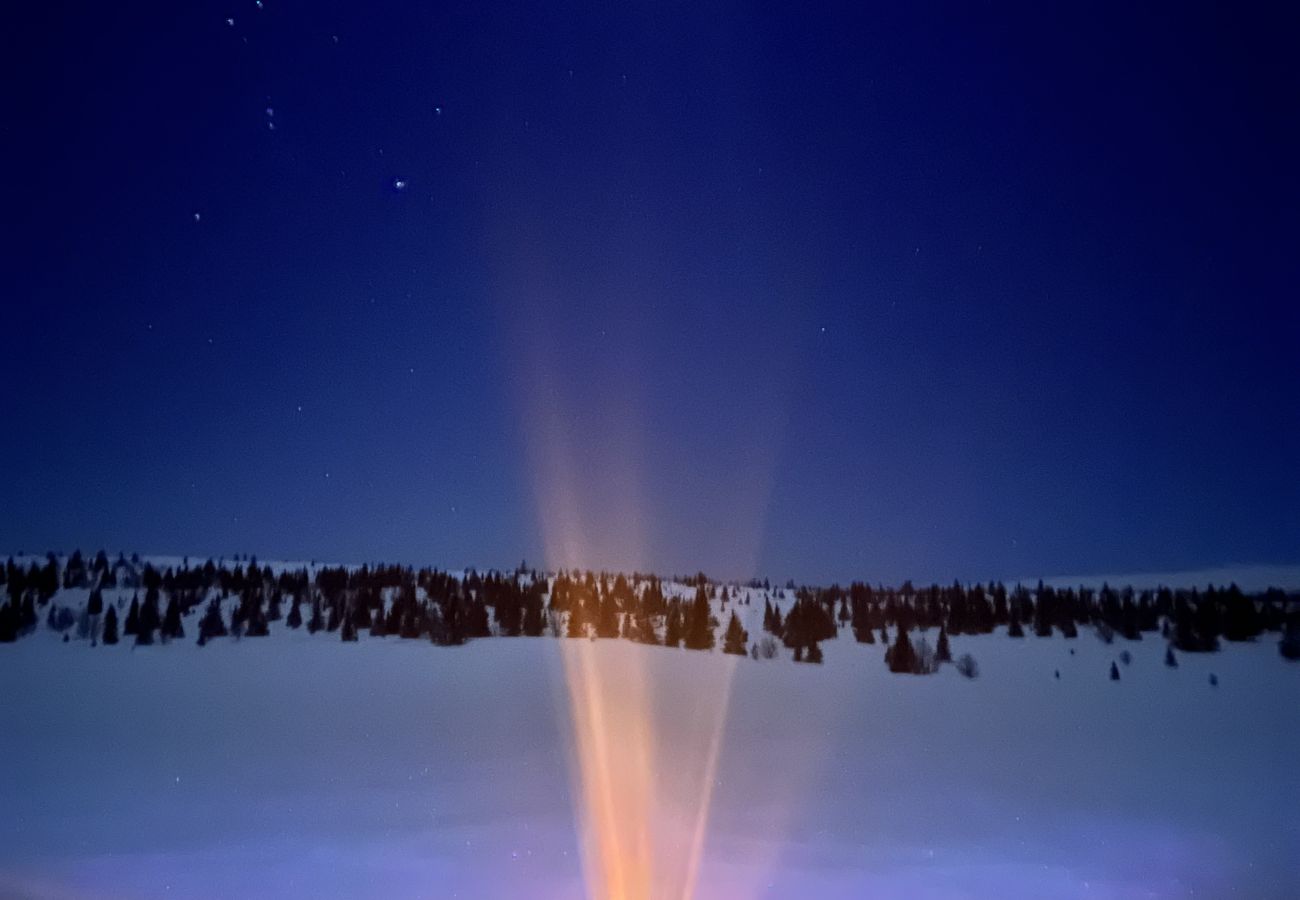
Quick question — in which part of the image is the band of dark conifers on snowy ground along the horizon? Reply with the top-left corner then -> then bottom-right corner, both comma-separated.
0,550 -> 1300,674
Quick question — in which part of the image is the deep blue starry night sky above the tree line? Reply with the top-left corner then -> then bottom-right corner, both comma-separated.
0,0 -> 1300,580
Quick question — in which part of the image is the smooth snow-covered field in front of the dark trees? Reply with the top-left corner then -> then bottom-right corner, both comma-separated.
0,598 -> 1300,899
